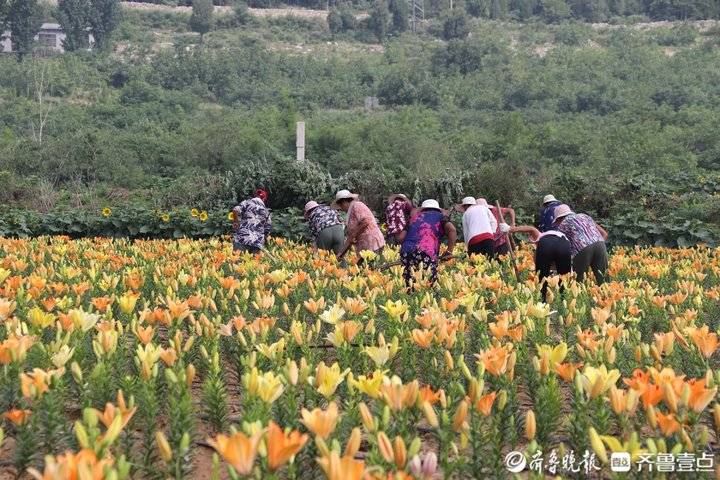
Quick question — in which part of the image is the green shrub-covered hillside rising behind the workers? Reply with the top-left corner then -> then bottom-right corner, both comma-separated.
0,2 -> 720,245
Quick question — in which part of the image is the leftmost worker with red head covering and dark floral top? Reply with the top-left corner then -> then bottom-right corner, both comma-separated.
232,189 -> 272,253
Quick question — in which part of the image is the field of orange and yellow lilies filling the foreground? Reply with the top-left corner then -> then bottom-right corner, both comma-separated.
0,237 -> 720,480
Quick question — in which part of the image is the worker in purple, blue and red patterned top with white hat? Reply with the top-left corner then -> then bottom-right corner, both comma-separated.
400,200 -> 457,291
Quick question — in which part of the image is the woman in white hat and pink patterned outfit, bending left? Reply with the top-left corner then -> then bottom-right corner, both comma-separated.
333,190 -> 385,257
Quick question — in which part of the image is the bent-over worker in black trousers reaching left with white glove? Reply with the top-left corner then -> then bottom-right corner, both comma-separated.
510,223 -> 572,302
